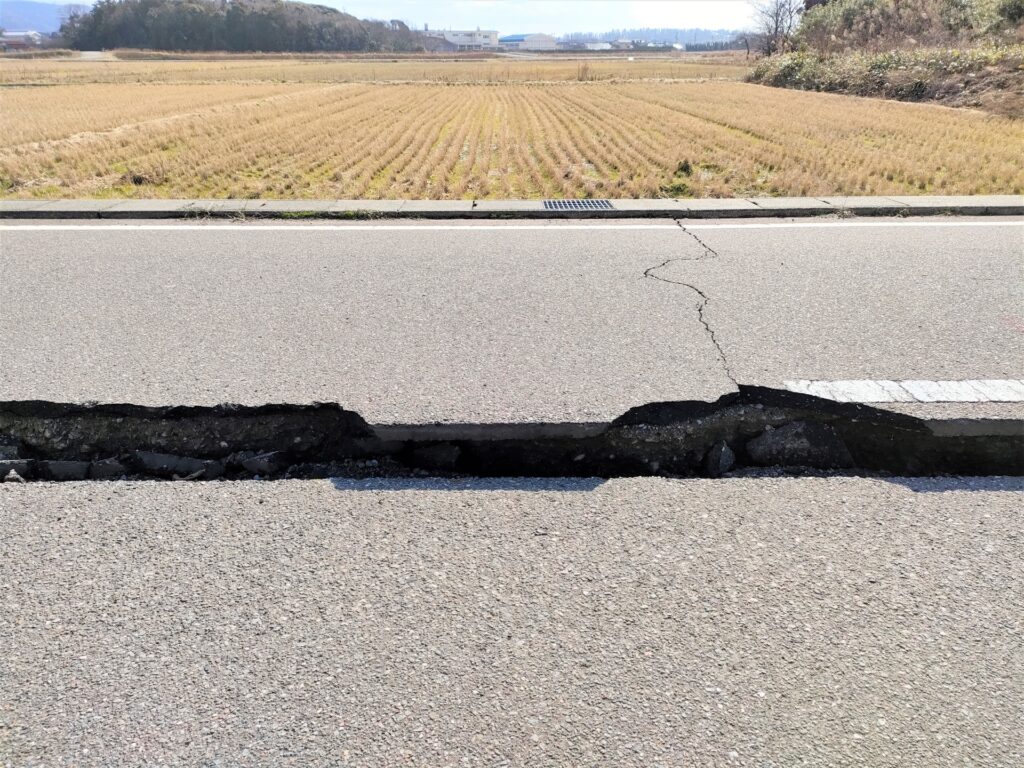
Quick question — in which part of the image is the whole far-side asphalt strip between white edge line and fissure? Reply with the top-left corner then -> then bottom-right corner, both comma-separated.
0,219 -> 1024,424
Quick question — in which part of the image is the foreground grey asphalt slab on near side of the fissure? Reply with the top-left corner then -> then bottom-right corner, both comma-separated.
0,478 -> 1024,768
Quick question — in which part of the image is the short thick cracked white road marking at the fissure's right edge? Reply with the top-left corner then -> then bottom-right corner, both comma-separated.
783,379 -> 1024,402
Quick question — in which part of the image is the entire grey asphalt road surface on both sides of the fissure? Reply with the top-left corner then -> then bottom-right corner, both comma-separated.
0,220 -> 1024,768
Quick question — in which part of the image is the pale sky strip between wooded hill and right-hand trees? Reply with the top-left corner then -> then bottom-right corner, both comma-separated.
331,0 -> 751,35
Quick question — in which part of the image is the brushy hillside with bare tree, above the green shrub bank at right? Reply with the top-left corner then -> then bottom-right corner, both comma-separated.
755,0 -> 1024,55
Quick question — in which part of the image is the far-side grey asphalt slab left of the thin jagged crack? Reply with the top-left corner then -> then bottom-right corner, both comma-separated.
0,220 -> 734,424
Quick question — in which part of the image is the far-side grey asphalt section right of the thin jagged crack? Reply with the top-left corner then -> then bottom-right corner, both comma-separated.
658,220 -> 1024,393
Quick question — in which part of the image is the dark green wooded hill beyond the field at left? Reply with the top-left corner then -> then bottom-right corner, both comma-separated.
60,0 -> 422,52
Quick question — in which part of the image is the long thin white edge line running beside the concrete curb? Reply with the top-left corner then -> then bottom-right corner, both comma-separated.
0,220 -> 1024,232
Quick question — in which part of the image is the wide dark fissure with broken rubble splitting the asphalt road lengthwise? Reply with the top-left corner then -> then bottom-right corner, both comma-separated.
0,385 -> 1024,481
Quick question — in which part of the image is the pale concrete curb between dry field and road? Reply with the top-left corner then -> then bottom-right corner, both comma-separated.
0,195 -> 1024,219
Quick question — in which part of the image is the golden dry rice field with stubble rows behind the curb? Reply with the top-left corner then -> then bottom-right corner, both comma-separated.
0,57 -> 1024,200
